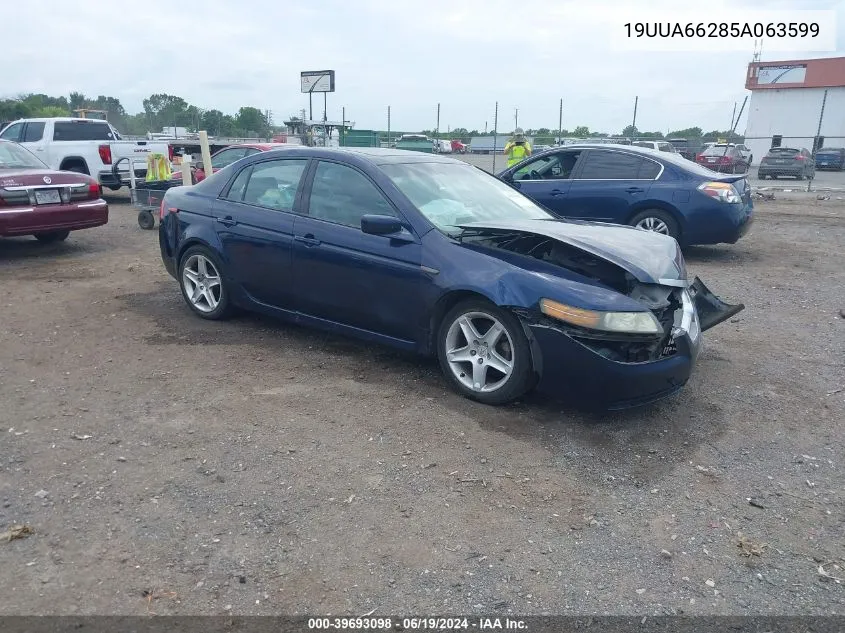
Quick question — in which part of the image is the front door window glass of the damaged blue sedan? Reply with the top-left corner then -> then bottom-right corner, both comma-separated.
308,161 -> 396,228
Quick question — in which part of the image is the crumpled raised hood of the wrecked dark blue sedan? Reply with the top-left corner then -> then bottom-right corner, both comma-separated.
460,219 -> 687,284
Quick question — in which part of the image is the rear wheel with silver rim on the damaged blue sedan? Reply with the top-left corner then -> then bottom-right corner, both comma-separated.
179,246 -> 232,321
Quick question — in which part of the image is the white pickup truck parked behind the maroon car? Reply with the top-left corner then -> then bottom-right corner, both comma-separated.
0,117 -> 173,191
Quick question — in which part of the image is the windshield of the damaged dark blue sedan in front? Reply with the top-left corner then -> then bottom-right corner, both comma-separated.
381,163 -> 554,234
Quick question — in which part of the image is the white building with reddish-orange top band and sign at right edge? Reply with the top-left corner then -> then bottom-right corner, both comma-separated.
745,57 -> 845,165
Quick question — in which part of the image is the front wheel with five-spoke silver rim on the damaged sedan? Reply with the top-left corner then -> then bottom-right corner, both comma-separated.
437,299 -> 534,405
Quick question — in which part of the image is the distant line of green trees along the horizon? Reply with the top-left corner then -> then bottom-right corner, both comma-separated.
0,92 -> 742,145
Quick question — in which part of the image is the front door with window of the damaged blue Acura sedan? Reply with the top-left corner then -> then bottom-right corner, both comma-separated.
294,160 -> 423,341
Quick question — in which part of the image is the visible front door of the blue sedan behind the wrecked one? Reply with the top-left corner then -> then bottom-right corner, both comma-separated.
508,150 -> 581,217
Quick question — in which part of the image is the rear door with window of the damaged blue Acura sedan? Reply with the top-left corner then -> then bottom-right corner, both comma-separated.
212,158 -> 308,310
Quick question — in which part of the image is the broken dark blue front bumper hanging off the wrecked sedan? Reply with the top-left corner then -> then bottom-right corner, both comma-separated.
522,278 -> 745,410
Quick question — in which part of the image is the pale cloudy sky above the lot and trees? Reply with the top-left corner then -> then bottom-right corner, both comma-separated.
6,0 -> 845,133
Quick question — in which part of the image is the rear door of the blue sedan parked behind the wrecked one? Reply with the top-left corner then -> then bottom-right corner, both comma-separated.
567,149 -> 662,224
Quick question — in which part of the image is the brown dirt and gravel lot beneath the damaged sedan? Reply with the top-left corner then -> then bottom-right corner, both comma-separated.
0,196 -> 845,615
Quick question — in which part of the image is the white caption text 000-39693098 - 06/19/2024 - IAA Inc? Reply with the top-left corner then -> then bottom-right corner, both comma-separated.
308,617 -> 528,631
